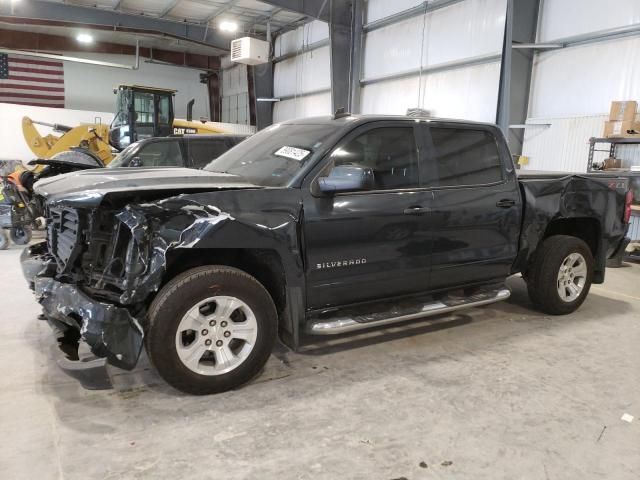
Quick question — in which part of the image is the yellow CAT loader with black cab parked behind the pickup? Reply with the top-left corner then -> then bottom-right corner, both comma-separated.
22,85 -> 226,168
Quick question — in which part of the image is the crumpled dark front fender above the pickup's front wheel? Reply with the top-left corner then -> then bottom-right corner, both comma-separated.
107,190 -> 301,305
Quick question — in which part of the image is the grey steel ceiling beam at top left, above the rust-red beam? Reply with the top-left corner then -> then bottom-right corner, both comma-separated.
0,0 -> 229,50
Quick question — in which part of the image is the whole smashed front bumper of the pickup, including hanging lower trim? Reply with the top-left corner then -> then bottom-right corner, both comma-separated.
21,244 -> 144,388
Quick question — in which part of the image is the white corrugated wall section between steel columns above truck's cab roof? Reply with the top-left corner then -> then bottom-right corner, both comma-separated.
361,0 -> 506,122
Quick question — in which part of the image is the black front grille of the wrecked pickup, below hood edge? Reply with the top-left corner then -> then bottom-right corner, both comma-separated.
47,208 -> 82,273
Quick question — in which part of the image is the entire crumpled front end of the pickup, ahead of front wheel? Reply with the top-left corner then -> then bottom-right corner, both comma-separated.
21,196 -> 240,376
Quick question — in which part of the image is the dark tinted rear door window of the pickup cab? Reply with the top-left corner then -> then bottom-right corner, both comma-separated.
430,128 -> 503,187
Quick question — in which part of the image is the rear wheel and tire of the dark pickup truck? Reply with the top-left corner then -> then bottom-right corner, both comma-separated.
526,235 -> 593,315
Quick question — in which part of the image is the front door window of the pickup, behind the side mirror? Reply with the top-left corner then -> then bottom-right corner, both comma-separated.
331,127 -> 419,190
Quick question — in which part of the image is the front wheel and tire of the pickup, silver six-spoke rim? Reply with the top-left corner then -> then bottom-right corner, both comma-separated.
145,266 -> 278,395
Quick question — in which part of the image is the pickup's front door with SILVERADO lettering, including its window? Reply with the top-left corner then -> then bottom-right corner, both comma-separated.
303,121 -> 432,308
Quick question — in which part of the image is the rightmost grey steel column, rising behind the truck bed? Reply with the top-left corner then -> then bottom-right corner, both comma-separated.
497,0 -> 540,154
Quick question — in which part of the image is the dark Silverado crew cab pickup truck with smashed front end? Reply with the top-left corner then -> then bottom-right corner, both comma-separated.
22,115 -> 631,394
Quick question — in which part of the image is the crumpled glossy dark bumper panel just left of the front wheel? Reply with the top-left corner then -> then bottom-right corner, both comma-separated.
34,277 -> 143,370
